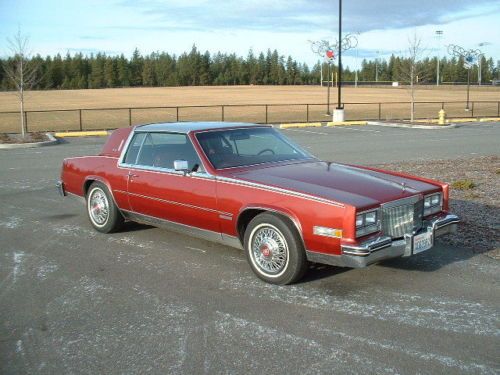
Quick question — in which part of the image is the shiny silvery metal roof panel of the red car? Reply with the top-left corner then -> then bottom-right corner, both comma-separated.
135,121 -> 271,133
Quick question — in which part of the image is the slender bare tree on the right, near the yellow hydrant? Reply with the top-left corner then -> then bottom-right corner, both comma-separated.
400,33 -> 428,121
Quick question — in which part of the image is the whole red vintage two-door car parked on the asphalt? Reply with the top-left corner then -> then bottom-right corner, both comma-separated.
58,122 -> 459,284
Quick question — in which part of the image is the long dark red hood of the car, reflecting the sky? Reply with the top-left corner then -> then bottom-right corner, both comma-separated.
223,161 -> 437,208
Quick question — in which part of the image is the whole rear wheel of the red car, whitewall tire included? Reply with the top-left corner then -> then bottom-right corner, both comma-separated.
86,181 -> 124,233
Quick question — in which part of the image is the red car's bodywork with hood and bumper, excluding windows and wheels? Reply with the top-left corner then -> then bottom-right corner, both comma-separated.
59,123 -> 459,282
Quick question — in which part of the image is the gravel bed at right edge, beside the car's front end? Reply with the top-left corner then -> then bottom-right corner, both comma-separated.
377,156 -> 500,259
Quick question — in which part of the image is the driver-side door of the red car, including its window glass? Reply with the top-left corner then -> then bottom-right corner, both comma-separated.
125,132 -> 220,233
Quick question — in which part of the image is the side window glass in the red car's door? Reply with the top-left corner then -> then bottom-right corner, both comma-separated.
131,133 -> 202,172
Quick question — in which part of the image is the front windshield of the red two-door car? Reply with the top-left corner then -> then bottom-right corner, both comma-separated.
196,128 -> 313,169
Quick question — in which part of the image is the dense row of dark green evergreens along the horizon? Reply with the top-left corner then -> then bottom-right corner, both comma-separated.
0,46 -> 500,90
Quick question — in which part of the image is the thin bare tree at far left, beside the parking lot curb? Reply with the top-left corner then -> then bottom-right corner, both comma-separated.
3,29 -> 38,138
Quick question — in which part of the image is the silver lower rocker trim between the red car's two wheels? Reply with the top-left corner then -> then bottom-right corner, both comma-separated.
121,210 -> 242,249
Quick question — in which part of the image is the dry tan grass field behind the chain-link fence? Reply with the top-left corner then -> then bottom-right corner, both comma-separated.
0,86 -> 500,132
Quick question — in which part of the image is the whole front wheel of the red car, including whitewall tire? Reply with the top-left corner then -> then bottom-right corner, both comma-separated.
244,213 -> 307,285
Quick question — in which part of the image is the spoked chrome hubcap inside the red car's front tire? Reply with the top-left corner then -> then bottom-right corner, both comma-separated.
252,226 -> 288,274
